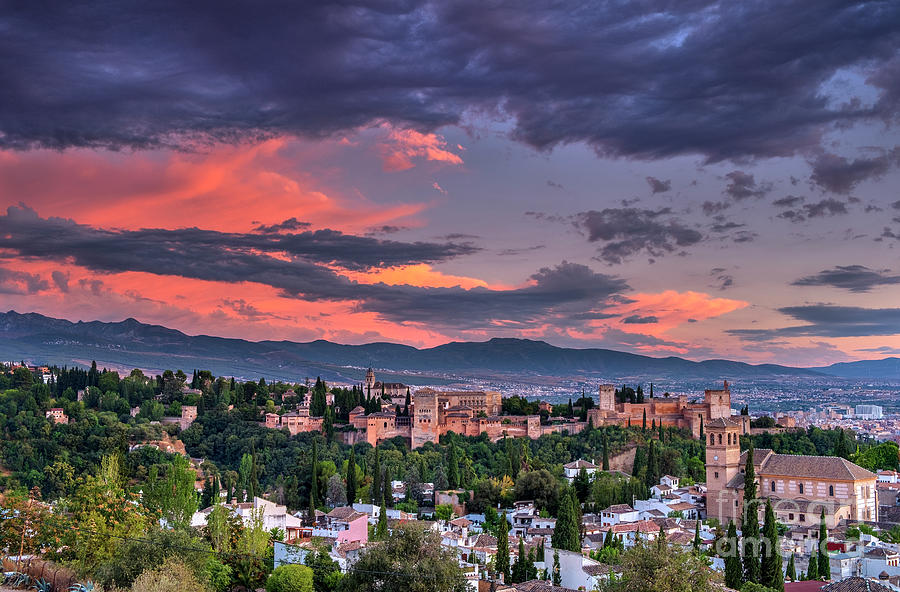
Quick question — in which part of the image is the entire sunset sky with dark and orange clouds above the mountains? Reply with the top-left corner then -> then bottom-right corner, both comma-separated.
0,0 -> 900,366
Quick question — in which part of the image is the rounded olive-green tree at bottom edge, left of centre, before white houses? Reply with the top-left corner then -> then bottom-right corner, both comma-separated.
338,524 -> 468,592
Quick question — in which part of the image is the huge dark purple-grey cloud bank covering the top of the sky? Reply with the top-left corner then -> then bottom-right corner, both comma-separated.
0,0 -> 900,161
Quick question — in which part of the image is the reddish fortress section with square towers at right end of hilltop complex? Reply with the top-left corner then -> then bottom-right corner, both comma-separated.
588,380 -> 731,438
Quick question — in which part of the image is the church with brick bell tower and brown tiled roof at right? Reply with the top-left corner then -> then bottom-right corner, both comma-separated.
704,416 -> 878,529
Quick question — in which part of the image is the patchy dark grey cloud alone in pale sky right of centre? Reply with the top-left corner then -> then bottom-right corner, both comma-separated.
574,208 -> 703,264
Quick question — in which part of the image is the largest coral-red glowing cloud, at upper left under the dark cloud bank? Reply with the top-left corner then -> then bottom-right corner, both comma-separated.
0,138 -> 427,232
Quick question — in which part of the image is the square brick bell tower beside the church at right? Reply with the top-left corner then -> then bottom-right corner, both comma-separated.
704,418 -> 743,525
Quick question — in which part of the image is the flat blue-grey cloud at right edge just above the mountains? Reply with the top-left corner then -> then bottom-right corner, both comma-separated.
727,304 -> 900,341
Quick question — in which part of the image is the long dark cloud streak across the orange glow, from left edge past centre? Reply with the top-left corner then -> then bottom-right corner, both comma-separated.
0,207 -> 629,329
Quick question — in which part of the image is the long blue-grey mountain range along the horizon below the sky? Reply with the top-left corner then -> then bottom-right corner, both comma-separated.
0,311 -> 852,384
